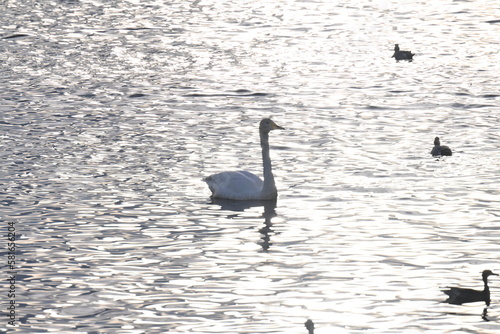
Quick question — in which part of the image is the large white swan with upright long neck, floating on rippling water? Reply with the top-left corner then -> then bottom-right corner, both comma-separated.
203,118 -> 284,200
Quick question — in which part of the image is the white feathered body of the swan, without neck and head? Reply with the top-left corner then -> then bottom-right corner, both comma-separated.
203,171 -> 264,200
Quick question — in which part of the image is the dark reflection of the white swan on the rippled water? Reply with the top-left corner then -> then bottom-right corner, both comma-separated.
211,197 -> 277,252
